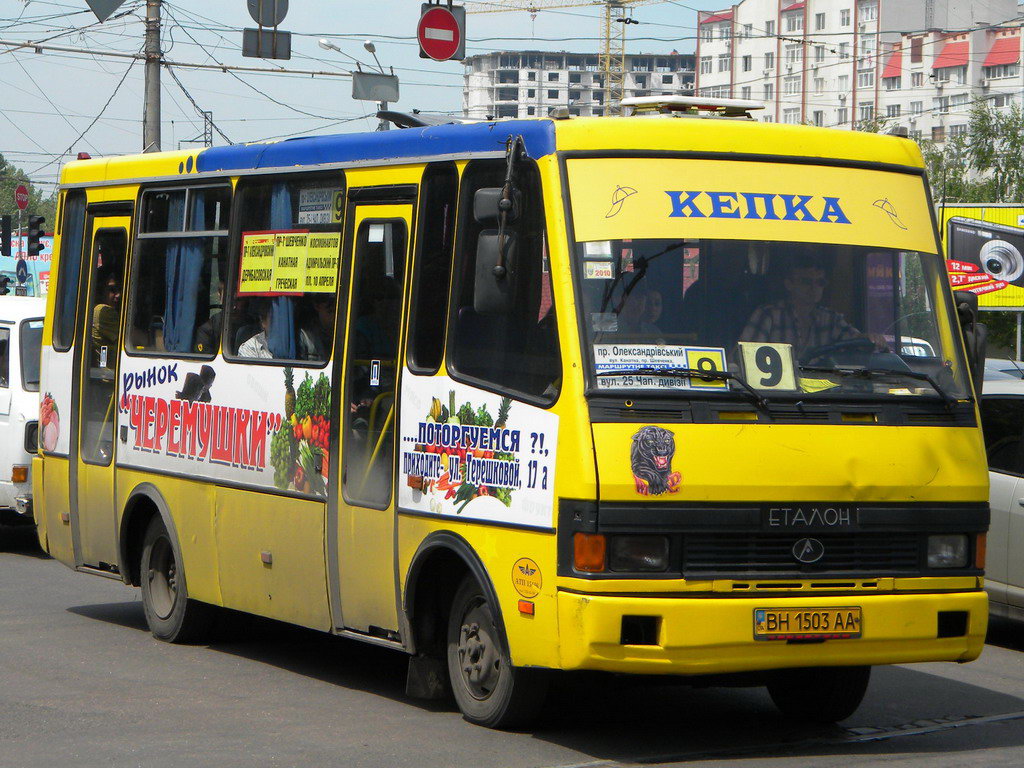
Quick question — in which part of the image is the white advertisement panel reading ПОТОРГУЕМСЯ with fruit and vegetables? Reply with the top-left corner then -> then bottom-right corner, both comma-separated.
398,373 -> 558,527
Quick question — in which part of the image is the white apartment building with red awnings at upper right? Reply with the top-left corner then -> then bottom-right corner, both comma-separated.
696,0 -> 1024,142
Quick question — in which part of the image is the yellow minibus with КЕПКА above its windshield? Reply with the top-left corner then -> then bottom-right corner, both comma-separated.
33,98 -> 988,727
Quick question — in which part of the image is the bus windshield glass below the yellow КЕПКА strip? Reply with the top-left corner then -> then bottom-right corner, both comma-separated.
574,238 -> 970,403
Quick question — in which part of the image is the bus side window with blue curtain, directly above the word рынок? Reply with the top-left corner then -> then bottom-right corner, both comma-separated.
126,184 -> 231,357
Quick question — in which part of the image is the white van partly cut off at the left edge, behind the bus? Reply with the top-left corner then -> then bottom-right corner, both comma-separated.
0,296 -> 46,540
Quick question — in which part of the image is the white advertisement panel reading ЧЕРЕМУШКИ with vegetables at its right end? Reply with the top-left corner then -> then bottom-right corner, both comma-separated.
118,354 -> 331,497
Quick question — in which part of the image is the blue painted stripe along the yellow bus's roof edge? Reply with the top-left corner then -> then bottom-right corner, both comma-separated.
196,120 -> 555,173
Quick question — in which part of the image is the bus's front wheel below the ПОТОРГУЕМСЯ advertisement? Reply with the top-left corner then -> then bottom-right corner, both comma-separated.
447,577 -> 548,729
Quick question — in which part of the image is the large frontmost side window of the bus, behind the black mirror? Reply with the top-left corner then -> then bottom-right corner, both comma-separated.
447,161 -> 561,403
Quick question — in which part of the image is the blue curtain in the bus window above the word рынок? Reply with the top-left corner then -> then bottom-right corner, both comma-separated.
164,189 -> 205,352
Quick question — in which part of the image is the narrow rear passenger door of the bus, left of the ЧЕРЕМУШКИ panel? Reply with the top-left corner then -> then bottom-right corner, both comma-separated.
72,215 -> 131,569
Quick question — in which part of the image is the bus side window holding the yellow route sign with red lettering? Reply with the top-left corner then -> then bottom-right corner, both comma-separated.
224,172 -> 345,365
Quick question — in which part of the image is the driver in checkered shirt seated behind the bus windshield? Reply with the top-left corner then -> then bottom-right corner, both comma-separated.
739,260 -> 889,360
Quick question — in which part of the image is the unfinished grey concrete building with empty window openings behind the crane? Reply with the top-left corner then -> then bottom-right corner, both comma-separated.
463,50 -> 694,118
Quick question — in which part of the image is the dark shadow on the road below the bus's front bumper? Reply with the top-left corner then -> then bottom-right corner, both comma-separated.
535,667 -> 1024,765
